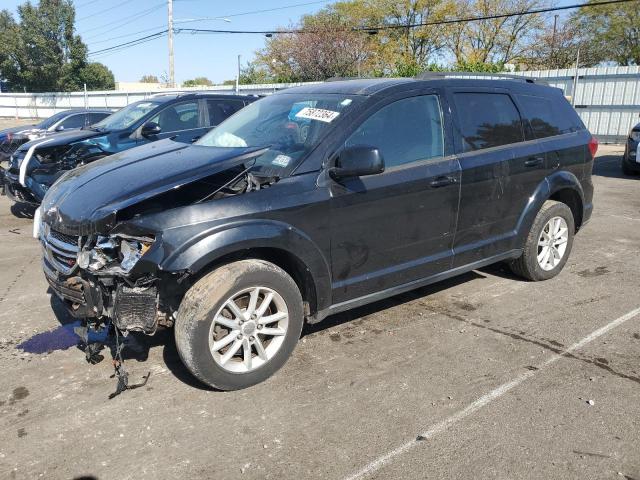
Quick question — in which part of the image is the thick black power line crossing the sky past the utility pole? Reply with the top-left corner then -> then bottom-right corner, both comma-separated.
90,0 -> 640,55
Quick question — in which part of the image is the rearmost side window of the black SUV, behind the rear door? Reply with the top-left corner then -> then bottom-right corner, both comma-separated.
518,95 -> 582,138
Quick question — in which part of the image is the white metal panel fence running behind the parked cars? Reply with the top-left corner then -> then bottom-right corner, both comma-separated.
0,67 -> 640,142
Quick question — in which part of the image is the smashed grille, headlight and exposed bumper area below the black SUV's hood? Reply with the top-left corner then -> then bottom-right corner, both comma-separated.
39,223 -> 166,335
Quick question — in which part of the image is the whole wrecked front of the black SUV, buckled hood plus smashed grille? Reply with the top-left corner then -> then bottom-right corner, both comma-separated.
34,141 -> 277,335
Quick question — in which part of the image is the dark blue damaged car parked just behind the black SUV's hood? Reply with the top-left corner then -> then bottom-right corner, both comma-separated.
5,93 -> 258,205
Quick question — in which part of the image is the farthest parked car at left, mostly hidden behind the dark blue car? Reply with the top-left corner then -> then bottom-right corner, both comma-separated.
0,108 -> 113,182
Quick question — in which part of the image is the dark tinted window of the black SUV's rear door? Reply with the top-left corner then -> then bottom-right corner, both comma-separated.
454,93 -> 524,152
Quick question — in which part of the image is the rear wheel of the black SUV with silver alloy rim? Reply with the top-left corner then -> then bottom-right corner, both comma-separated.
509,200 -> 575,282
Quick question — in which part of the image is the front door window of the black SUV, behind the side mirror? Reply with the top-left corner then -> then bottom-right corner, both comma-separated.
345,95 -> 444,167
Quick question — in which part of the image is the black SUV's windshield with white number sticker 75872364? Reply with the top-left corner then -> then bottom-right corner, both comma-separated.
196,93 -> 362,177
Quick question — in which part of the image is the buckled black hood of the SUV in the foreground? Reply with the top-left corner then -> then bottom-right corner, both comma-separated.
41,140 -> 265,235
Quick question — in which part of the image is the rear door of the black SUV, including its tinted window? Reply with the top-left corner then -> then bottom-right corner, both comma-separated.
444,88 -> 545,267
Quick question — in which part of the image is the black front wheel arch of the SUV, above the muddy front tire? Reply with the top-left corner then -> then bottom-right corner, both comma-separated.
160,220 -> 331,309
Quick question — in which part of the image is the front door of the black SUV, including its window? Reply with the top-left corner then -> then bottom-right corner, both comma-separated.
330,92 -> 460,303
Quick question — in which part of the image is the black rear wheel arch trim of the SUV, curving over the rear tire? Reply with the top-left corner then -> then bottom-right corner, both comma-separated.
514,170 -> 585,248
